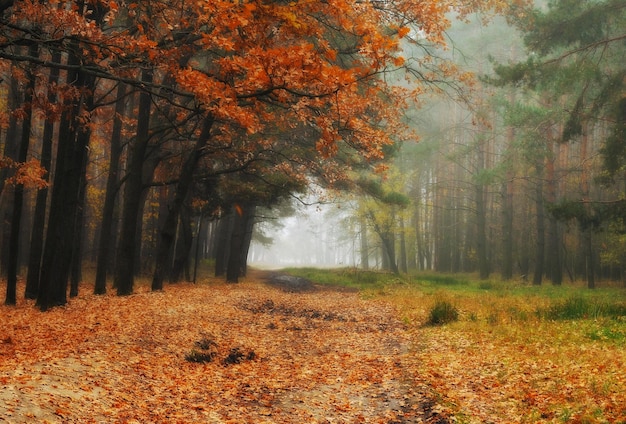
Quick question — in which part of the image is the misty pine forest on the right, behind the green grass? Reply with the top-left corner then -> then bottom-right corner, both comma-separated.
253,1 -> 626,288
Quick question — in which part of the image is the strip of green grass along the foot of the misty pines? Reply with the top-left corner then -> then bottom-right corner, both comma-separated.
283,268 -> 626,326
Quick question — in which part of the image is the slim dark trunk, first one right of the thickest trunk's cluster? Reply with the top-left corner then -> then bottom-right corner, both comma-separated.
94,84 -> 126,294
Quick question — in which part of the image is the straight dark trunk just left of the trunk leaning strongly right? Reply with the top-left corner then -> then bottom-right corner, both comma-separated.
113,70 -> 153,296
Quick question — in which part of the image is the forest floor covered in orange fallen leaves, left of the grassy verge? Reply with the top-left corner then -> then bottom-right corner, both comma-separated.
0,273 -> 448,424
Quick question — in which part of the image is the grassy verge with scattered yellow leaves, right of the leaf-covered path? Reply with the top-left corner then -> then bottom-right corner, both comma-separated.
282,269 -> 626,423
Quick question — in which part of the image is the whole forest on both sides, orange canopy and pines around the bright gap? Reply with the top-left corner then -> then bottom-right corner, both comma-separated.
0,0 -> 626,296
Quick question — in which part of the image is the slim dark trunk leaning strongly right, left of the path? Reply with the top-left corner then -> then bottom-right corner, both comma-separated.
152,116 -> 214,290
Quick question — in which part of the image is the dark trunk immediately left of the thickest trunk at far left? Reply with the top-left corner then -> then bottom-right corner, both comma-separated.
25,53 -> 61,299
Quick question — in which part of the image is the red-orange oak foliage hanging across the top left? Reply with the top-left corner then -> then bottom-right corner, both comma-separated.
0,0 -> 503,177
